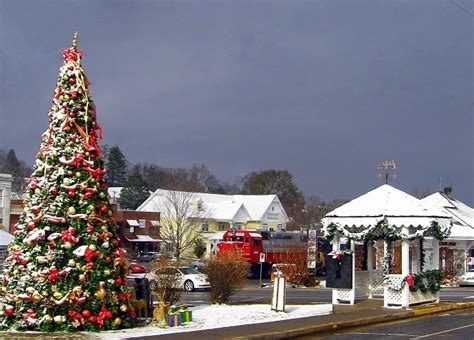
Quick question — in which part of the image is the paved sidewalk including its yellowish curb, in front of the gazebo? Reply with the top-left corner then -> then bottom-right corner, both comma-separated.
141,300 -> 474,340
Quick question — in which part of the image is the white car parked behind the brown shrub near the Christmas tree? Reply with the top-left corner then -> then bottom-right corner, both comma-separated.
145,267 -> 211,292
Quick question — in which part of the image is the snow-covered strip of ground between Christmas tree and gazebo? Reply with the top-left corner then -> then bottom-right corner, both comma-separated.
94,304 -> 332,340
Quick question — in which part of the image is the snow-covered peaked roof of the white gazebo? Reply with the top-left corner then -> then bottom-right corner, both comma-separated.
323,184 -> 450,227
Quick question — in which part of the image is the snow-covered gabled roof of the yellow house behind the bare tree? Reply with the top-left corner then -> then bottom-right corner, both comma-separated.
137,189 -> 288,222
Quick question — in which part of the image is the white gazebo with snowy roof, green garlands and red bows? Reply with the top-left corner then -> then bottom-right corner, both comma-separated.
323,184 -> 451,308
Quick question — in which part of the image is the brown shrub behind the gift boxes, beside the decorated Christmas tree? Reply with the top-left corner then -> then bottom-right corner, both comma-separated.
150,257 -> 181,305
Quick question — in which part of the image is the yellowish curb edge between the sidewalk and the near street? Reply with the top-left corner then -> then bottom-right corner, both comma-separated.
232,302 -> 474,340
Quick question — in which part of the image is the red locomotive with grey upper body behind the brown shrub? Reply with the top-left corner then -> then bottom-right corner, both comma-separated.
217,230 -> 308,277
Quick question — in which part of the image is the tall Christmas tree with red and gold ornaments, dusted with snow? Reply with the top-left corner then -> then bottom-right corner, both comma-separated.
0,35 -> 135,331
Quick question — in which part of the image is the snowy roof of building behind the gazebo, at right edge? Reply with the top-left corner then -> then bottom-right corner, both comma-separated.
421,192 -> 474,240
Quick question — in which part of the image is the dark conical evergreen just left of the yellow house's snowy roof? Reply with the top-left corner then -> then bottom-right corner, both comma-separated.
117,166 -> 150,210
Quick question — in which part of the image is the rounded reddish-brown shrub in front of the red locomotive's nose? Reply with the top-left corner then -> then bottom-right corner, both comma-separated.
207,251 -> 250,304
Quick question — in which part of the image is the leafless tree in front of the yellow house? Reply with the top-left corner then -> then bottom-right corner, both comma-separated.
155,190 -> 208,260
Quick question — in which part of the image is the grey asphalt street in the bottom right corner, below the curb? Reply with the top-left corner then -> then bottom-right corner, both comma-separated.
296,309 -> 474,340
